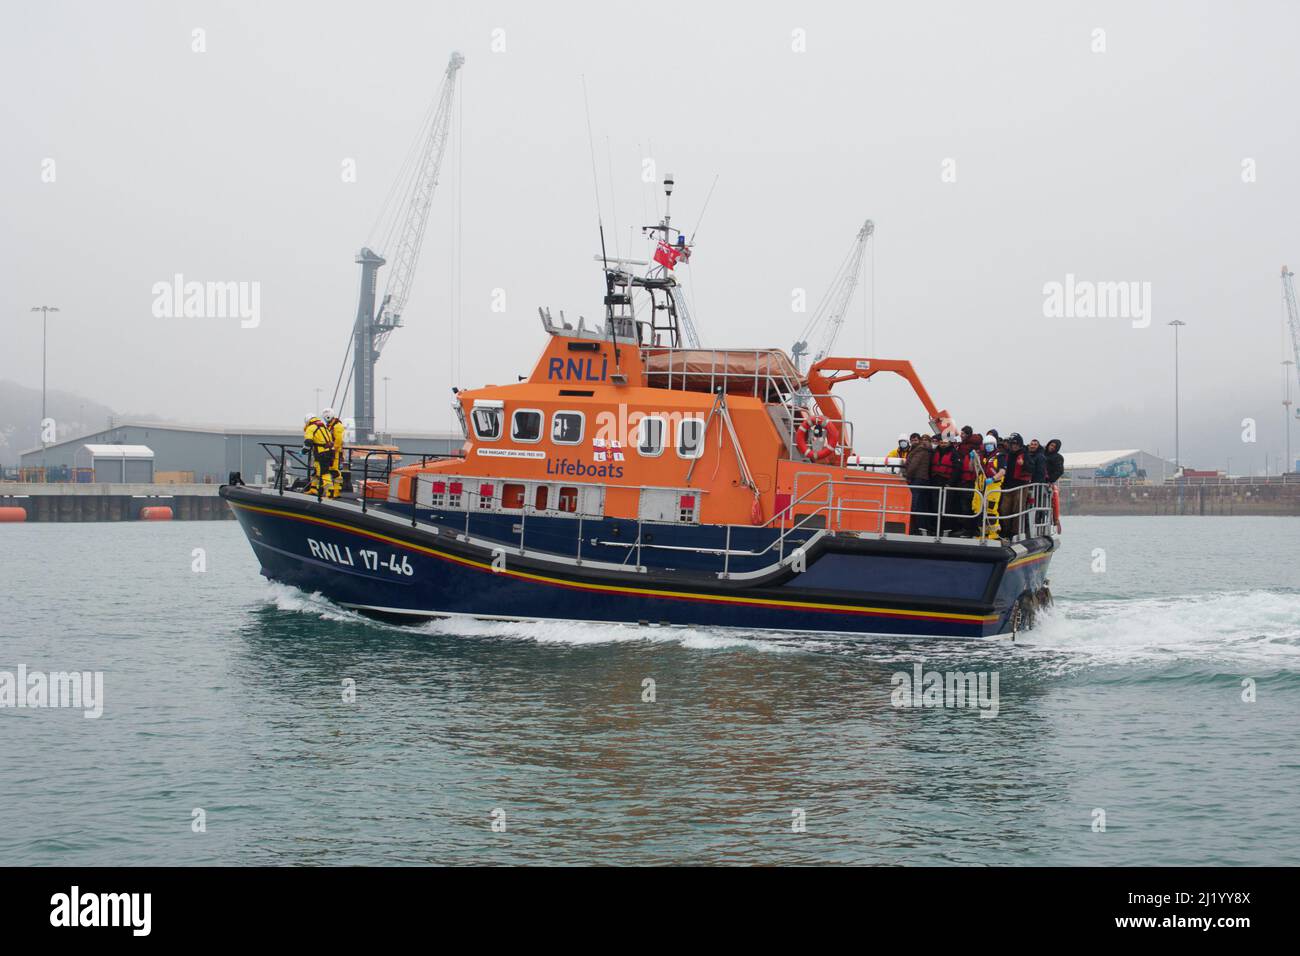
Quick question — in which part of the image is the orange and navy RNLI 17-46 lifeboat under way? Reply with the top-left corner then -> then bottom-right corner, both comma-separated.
221,191 -> 1057,637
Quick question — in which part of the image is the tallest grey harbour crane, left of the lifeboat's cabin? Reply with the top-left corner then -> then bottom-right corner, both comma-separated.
335,52 -> 465,441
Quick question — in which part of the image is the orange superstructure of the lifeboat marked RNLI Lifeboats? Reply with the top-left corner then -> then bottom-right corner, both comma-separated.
384,316 -> 948,532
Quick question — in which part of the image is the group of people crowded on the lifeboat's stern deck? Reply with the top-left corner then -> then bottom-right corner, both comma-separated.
888,425 -> 1065,540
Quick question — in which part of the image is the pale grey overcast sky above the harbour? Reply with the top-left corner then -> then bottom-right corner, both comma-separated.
0,3 -> 1300,471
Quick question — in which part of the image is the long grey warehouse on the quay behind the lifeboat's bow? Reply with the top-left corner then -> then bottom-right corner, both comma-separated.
21,421 -> 464,484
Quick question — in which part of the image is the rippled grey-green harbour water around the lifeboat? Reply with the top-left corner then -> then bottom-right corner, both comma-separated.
0,518 -> 1300,865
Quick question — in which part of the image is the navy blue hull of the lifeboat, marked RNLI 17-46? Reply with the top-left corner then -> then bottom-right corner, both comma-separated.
222,488 -> 1054,637
